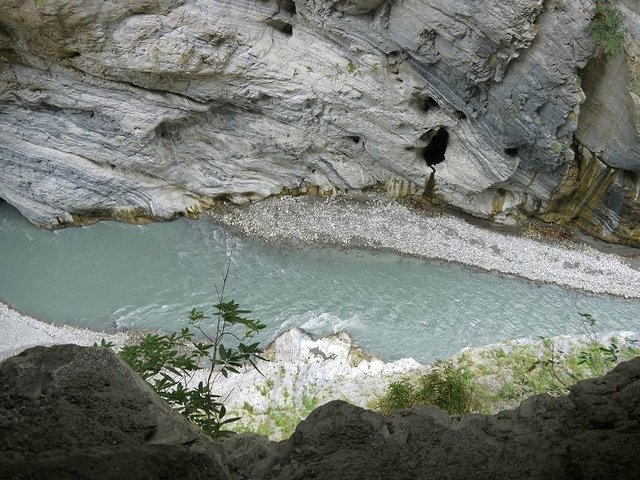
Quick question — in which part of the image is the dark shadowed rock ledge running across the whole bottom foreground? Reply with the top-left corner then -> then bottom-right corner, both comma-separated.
0,345 -> 640,479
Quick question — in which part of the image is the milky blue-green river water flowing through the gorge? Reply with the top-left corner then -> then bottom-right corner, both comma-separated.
0,203 -> 640,362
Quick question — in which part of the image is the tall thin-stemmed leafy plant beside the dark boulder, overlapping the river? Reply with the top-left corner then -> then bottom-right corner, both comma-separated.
119,268 -> 265,437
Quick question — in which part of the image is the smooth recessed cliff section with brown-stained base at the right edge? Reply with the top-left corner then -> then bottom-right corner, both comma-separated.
543,0 -> 640,245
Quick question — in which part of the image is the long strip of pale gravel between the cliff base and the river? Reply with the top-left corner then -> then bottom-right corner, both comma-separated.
211,193 -> 640,298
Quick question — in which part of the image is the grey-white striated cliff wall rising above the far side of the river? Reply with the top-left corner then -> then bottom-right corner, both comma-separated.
0,0 -> 640,245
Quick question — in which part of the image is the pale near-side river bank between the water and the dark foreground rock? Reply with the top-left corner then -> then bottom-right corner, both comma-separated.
0,303 -> 640,440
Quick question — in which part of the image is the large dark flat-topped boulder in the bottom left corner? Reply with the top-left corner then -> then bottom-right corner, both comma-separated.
0,345 -> 228,480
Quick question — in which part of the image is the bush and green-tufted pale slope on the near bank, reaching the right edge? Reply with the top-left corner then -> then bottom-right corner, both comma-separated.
372,313 -> 640,415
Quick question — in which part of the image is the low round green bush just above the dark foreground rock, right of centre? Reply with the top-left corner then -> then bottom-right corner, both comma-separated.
374,362 -> 479,415
